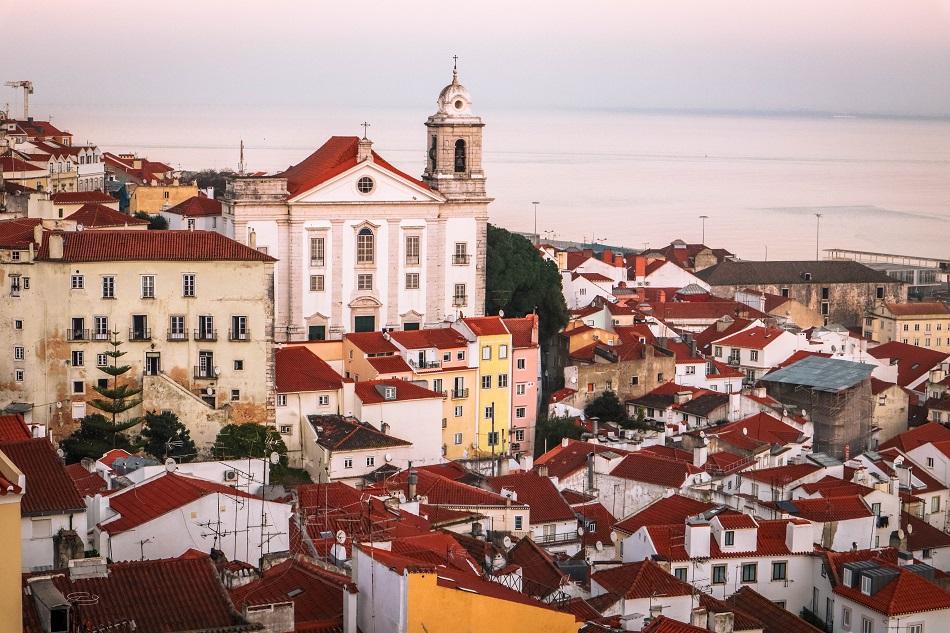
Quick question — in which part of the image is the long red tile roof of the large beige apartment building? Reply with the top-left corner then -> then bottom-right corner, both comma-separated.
37,230 -> 277,262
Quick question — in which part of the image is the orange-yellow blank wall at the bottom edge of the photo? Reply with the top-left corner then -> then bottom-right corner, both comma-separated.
406,573 -> 580,633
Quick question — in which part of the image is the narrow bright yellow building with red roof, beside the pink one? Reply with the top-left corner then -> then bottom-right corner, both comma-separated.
453,316 -> 512,457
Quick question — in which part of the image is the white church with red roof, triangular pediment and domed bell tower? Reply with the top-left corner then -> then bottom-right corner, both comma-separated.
223,69 -> 491,342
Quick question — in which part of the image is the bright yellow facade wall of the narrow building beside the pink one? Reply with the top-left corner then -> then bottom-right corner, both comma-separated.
475,334 -> 513,456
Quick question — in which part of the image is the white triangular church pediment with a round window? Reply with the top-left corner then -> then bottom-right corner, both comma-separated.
290,161 -> 444,204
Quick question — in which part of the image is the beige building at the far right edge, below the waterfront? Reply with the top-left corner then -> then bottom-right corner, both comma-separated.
864,301 -> 950,352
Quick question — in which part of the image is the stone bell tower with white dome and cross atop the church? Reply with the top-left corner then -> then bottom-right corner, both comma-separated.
422,62 -> 485,199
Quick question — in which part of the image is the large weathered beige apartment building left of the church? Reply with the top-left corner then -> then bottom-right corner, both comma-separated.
0,223 -> 274,446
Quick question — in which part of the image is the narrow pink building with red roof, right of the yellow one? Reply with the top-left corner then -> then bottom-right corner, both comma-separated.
505,314 -> 541,455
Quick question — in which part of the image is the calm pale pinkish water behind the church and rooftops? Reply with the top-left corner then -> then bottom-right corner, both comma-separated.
46,104 -> 950,259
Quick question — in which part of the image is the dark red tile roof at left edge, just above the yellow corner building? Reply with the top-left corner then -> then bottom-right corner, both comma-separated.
0,437 -> 86,516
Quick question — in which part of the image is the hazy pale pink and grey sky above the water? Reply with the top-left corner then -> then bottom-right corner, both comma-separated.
0,0 -> 950,117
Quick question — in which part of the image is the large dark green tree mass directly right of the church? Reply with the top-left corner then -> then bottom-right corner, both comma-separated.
485,224 -> 568,339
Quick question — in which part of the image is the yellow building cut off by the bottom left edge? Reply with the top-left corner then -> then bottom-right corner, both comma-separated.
0,451 -> 25,631
